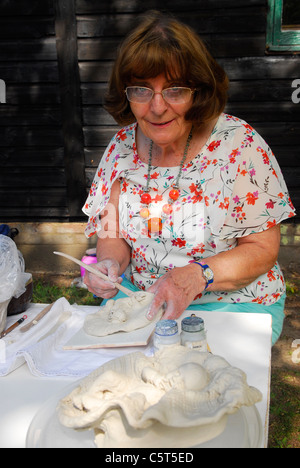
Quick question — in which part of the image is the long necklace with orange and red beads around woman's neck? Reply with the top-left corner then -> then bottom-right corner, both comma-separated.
140,127 -> 193,233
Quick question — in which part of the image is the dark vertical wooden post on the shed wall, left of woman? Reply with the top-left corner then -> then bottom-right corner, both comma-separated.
54,0 -> 86,218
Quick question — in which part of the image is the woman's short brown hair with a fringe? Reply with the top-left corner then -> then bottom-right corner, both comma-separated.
105,11 -> 229,125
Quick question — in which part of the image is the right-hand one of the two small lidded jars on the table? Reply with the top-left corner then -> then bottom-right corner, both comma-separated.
180,314 -> 207,352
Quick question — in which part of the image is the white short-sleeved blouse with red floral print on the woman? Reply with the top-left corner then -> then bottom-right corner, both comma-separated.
83,114 -> 295,305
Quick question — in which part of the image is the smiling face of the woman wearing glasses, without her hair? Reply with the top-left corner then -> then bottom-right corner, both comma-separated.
130,74 -> 192,146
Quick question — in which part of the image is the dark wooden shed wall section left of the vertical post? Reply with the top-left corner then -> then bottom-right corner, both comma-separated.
0,0 -> 68,221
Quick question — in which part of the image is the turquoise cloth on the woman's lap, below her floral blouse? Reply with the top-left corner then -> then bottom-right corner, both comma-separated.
101,278 -> 286,346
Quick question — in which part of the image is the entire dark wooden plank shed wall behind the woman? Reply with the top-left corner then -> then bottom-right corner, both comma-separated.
0,0 -> 300,222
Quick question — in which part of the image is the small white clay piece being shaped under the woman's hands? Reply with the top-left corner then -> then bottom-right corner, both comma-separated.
83,291 -> 160,336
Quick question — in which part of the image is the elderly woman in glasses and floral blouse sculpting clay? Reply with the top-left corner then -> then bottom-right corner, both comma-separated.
83,12 -> 294,343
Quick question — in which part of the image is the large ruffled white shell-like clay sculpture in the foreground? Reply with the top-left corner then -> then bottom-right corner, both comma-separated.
58,346 -> 262,447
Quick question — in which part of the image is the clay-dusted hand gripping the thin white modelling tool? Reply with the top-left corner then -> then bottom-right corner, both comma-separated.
84,259 -> 122,299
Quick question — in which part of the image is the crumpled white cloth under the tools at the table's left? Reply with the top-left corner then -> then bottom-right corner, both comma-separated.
0,298 -> 143,378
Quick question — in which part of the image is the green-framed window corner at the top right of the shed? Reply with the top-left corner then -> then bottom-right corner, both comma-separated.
267,0 -> 300,53
